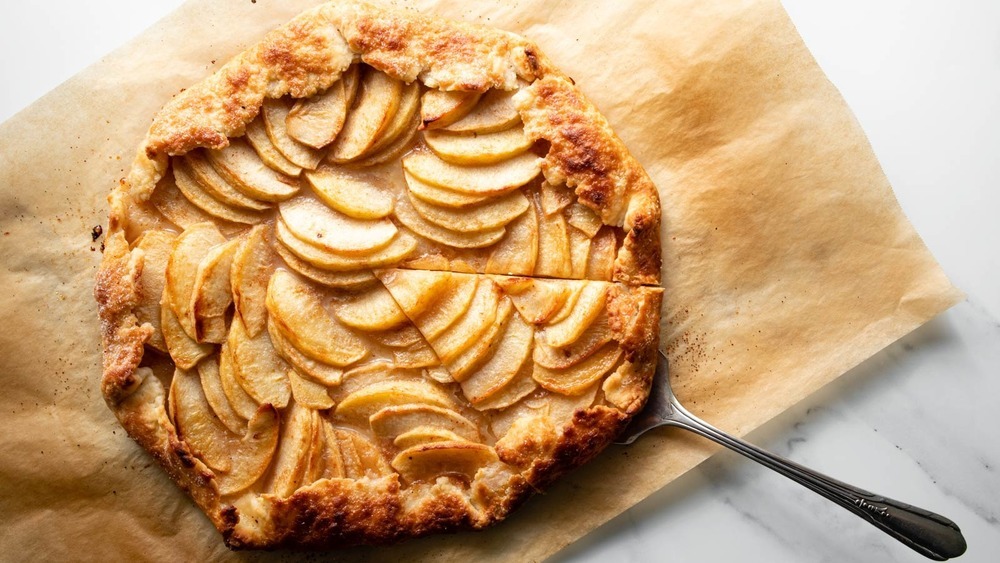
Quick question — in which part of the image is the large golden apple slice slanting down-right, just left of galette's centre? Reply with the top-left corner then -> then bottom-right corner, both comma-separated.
266,270 -> 368,367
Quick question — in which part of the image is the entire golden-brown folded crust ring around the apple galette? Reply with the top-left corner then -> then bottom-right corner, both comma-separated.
95,2 -> 660,548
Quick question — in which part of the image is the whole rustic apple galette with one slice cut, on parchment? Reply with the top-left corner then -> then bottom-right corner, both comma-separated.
95,2 -> 660,548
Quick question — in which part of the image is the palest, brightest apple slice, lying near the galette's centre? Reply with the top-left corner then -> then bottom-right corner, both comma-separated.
278,197 -> 398,255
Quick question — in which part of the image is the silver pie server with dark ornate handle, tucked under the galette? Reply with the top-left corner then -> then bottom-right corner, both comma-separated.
616,352 -> 966,561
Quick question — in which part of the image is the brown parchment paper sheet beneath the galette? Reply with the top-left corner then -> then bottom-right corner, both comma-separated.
0,0 -> 961,561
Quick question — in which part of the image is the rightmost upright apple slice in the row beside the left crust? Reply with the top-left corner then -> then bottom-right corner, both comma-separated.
229,225 -> 274,338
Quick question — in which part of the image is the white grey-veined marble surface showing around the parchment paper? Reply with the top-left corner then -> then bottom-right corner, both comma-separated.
0,0 -> 1000,563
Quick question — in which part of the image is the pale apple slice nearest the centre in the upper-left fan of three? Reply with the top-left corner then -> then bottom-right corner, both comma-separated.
205,139 -> 299,201
